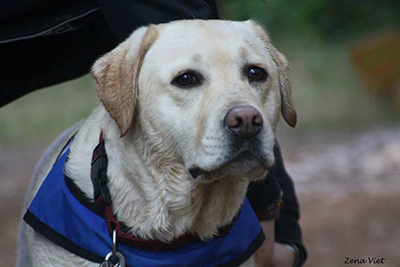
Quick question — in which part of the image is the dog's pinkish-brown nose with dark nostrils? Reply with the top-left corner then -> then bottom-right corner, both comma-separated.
224,106 -> 263,138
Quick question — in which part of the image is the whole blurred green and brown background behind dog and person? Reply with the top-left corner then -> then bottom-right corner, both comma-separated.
0,0 -> 400,267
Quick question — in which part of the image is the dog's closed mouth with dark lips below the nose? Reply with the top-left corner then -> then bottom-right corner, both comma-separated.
189,148 -> 272,179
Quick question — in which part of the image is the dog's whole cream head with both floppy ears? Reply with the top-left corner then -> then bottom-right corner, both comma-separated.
92,20 -> 296,181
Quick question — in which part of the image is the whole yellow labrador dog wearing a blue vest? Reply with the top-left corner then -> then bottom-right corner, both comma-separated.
18,20 -> 296,266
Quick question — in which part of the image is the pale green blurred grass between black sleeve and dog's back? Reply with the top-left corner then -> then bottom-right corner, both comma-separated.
0,76 -> 99,146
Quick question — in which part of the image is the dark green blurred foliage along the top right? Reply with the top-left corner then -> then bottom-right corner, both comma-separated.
219,0 -> 400,42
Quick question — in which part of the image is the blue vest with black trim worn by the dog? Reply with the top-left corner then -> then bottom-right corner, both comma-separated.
24,141 -> 265,267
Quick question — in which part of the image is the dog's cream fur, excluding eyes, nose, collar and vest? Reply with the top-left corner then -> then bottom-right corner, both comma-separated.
19,20 -> 296,266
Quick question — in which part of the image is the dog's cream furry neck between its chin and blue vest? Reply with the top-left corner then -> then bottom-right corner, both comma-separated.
66,107 -> 248,241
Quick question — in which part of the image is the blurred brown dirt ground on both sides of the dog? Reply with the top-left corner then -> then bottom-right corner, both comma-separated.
0,127 -> 400,267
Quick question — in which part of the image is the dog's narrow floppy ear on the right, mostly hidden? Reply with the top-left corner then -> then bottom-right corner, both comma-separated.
249,20 -> 297,127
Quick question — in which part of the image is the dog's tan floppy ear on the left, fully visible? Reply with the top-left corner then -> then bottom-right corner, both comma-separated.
91,26 -> 158,137
